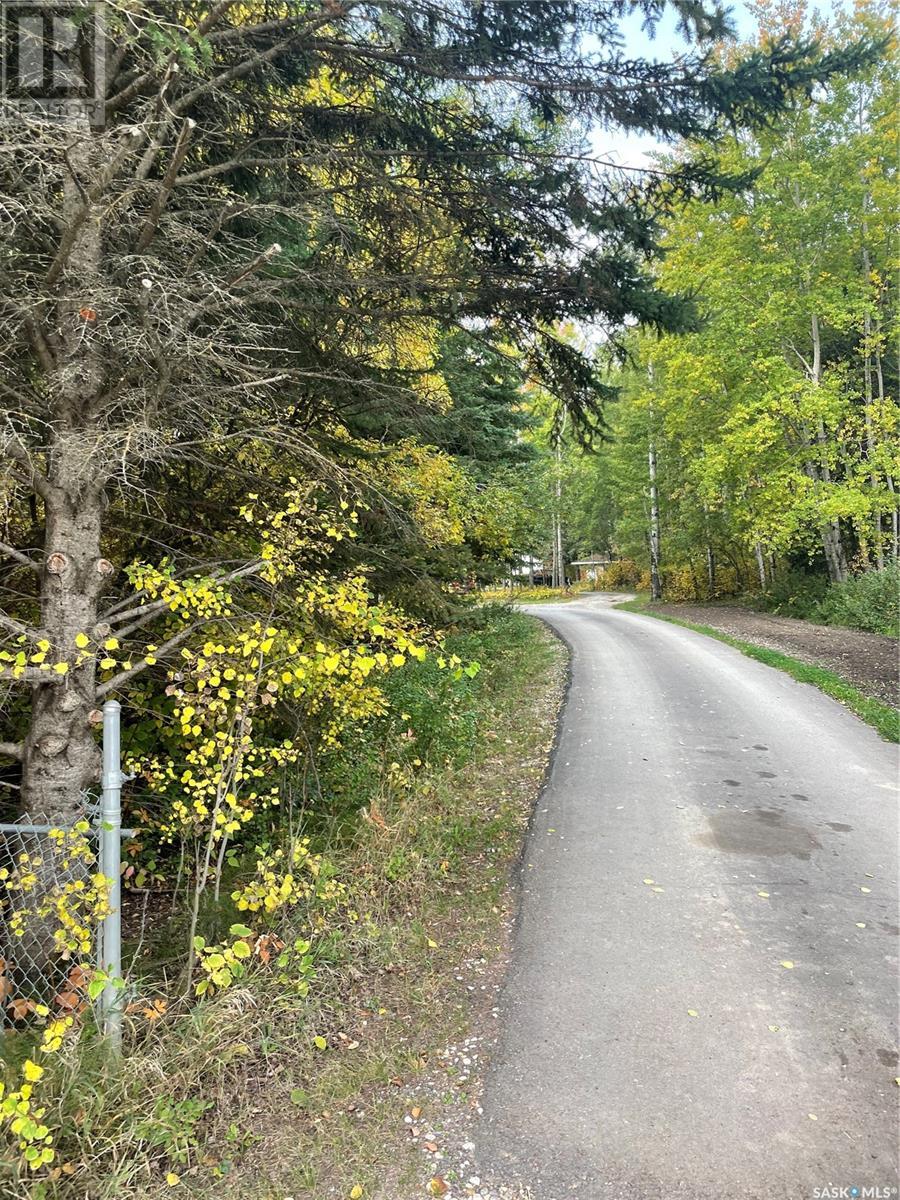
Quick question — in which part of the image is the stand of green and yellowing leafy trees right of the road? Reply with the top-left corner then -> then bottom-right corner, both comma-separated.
525,6 -> 899,635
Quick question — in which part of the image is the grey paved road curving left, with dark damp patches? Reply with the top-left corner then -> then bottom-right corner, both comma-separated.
476,601 -> 900,1200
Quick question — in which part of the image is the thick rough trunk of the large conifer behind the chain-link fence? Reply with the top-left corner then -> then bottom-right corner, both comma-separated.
22,121 -> 113,821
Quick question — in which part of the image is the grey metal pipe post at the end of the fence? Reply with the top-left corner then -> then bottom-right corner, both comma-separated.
100,700 -> 122,1054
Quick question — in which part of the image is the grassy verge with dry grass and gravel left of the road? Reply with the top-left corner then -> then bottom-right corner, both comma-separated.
8,608 -> 564,1200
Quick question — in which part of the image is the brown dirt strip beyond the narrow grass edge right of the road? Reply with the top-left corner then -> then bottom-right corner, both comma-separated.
649,604 -> 900,706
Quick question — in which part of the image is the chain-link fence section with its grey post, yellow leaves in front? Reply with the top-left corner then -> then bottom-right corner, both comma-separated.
0,701 -> 132,1046
